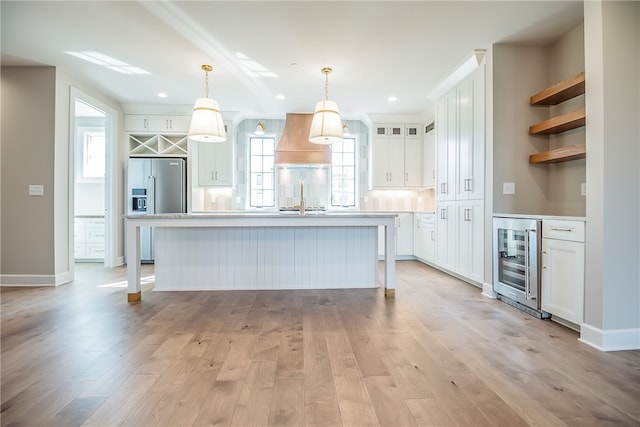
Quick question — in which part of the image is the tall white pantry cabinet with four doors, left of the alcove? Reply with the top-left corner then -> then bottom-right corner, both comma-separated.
436,65 -> 485,283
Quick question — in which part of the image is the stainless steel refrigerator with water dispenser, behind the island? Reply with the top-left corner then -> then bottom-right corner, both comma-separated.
127,157 -> 187,263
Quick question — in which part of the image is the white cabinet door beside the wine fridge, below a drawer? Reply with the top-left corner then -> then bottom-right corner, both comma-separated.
542,238 -> 584,325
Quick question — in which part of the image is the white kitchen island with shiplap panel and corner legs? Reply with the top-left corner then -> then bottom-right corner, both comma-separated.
126,212 -> 397,302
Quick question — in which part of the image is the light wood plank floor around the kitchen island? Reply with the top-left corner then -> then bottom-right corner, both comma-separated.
1,261 -> 640,427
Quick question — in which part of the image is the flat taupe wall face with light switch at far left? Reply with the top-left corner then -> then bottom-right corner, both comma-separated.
1,67 -> 56,275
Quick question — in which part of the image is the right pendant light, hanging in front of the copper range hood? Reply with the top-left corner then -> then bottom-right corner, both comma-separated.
309,67 -> 343,144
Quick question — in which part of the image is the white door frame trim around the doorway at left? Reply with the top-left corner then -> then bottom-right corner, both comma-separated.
69,86 -> 122,268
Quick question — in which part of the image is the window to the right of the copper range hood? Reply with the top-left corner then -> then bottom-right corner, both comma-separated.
331,137 -> 356,207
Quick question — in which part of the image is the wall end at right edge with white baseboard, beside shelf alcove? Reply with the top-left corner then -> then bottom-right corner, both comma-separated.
581,1 -> 640,350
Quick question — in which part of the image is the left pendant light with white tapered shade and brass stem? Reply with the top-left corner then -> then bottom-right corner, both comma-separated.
189,64 -> 227,142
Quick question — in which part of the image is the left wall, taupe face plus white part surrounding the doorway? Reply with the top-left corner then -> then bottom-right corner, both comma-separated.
0,67 -> 125,284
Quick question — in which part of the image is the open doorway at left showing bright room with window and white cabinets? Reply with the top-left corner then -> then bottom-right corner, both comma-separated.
69,88 -> 117,267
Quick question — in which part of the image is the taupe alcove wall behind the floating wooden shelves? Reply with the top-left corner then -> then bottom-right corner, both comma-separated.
492,25 -> 585,216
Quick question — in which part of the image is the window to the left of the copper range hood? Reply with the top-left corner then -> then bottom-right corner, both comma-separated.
249,136 -> 276,208
